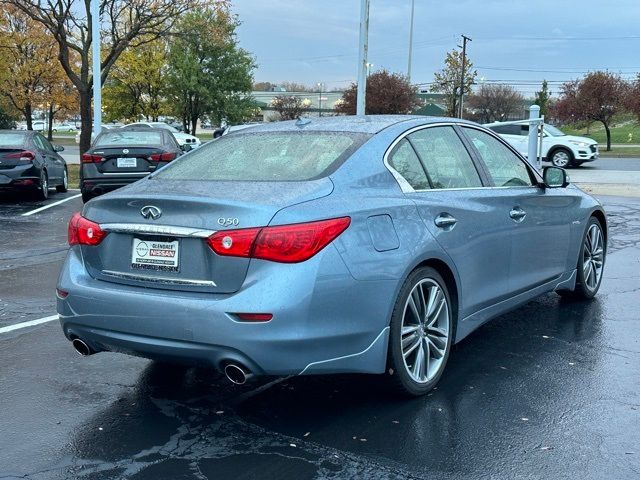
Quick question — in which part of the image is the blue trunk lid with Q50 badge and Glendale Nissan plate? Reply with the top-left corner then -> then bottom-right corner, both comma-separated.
82,178 -> 333,293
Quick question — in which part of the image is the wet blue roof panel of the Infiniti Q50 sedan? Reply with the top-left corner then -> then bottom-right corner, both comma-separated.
229,115 -> 472,134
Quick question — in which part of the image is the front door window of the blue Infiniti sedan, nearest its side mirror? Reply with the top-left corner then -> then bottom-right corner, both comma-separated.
463,127 -> 534,187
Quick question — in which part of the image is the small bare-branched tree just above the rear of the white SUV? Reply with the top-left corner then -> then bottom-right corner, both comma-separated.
468,85 -> 524,123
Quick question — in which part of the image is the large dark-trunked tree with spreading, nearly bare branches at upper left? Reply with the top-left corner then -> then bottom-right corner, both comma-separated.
0,0 -> 203,153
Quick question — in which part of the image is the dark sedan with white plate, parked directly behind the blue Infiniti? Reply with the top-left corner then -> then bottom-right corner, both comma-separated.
80,127 -> 183,202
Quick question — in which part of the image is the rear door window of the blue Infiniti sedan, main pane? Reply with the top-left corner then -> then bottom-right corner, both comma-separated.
409,127 -> 482,188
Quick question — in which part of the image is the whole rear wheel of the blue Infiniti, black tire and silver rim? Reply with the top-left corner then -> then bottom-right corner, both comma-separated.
387,267 -> 454,396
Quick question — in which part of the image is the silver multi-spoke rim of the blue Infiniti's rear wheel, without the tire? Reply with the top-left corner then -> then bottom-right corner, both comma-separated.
401,278 -> 451,383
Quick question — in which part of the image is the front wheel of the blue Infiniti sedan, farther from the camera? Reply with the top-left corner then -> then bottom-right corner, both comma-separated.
557,217 -> 607,300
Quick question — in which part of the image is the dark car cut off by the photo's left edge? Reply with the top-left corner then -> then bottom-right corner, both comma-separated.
0,130 -> 69,200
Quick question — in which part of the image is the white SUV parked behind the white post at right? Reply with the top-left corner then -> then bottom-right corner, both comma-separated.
485,122 -> 600,168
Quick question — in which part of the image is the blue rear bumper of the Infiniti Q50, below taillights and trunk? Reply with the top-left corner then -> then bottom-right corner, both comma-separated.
57,246 -> 396,375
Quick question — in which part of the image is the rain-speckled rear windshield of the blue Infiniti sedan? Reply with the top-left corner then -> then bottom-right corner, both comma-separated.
154,132 -> 368,182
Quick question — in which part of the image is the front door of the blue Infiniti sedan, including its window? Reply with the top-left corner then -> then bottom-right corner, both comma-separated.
463,126 -> 577,294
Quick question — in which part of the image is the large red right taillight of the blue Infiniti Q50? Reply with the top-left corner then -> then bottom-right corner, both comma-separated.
207,217 -> 351,263
